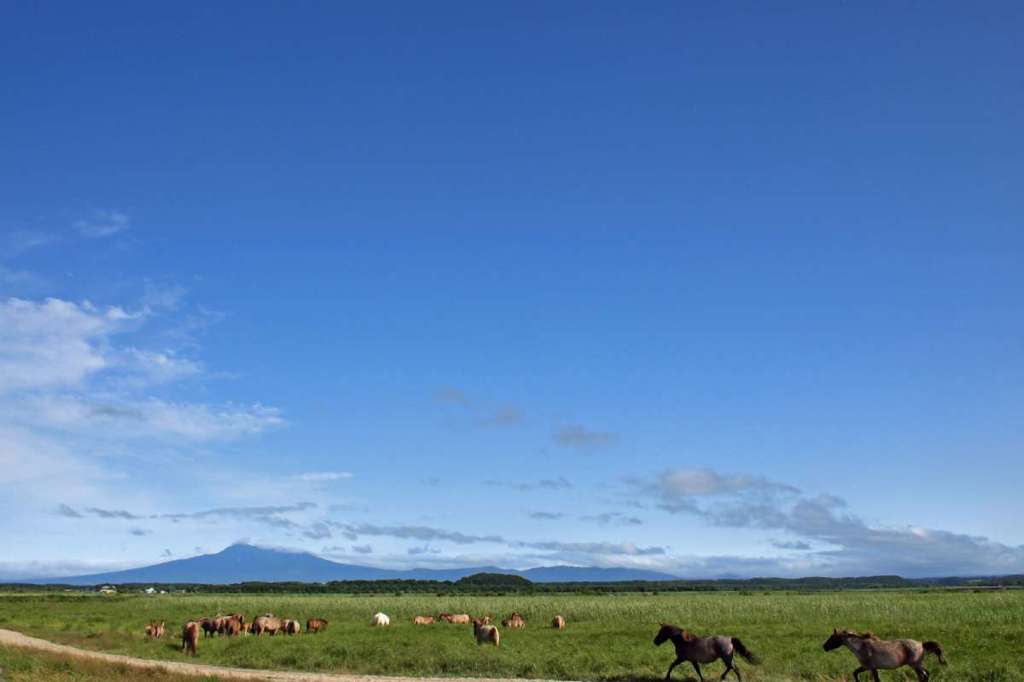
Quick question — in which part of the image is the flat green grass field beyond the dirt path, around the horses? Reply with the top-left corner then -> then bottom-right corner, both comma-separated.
0,591 -> 1024,682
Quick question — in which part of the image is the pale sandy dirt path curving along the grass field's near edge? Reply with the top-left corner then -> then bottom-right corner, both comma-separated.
0,629 -> 577,682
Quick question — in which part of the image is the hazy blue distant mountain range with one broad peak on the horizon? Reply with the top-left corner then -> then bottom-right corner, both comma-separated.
22,544 -> 678,586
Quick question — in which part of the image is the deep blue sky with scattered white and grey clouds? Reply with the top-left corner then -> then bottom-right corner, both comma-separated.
0,2 -> 1024,577
